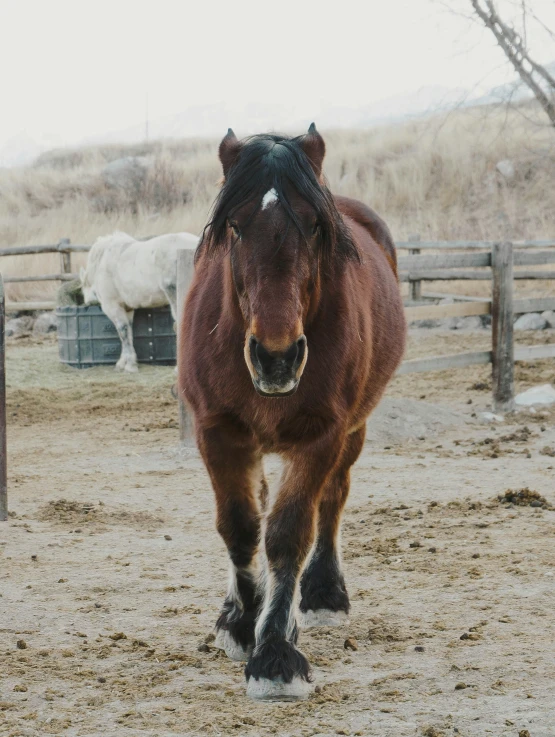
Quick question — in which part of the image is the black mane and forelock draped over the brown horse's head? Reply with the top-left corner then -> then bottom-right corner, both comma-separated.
197,134 -> 360,263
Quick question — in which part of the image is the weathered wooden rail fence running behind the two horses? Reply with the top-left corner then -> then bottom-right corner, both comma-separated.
0,235 -> 555,410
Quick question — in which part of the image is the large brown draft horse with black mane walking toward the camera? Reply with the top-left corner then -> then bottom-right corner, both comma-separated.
179,124 -> 406,700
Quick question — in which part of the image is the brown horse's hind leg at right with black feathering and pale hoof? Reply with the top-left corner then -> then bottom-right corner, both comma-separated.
300,425 -> 366,627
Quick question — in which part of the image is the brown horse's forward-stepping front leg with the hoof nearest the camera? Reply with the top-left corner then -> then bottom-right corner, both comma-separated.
245,435 -> 341,700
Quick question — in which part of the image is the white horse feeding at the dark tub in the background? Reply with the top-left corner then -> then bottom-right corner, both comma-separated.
80,231 -> 198,371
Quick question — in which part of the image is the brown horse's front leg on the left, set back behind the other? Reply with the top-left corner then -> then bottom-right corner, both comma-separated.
197,420 -> 265,660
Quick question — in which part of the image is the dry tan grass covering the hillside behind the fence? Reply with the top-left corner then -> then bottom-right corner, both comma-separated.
0,106 -> 555,298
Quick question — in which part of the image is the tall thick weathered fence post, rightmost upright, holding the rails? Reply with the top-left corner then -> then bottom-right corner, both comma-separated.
491,243 -> 515,412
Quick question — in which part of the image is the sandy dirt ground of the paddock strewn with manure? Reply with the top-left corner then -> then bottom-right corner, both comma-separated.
0,330 -> 555,737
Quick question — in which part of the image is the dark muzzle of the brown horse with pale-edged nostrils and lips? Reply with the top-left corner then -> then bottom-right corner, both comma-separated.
248,335 -> 307,397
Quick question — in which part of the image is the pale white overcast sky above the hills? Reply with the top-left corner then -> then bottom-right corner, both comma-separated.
0,0 -> 555,148
